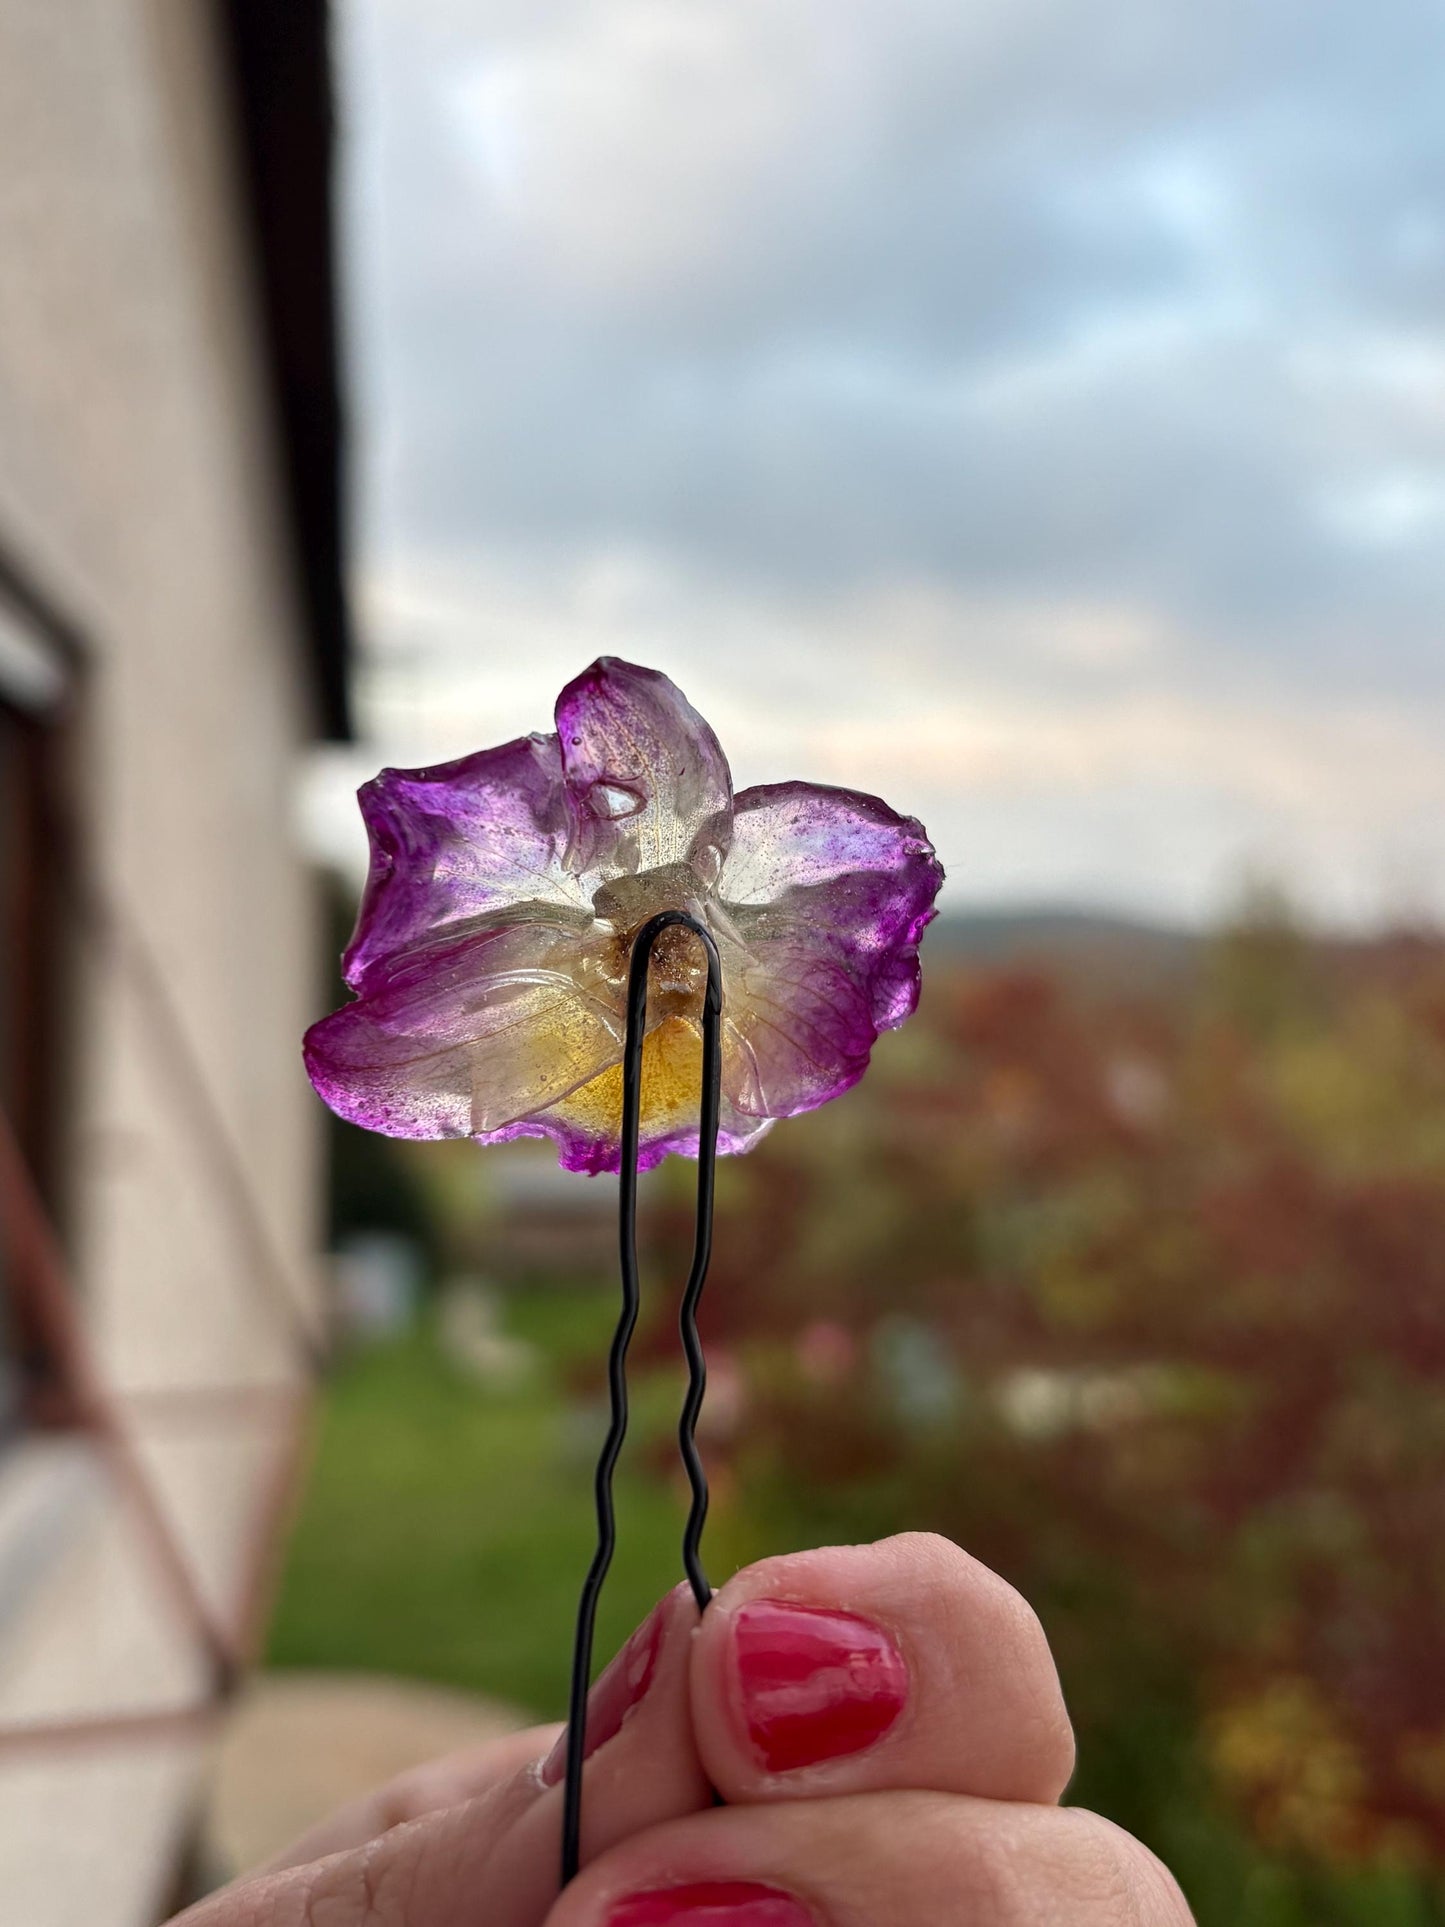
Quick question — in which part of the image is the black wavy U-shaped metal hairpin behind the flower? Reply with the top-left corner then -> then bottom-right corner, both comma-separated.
563,910 -> 723,1885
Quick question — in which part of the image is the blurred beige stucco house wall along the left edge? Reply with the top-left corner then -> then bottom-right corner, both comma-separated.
0,0 -> 331,1927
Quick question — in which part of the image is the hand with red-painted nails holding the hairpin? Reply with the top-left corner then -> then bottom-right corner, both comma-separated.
175,1534 -> 1191,1927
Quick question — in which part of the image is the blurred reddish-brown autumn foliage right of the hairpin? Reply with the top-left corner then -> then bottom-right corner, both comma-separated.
653,902 -> 1445,1927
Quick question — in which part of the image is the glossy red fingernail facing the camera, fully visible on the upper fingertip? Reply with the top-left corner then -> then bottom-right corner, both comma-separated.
732,1599 -> 907,1773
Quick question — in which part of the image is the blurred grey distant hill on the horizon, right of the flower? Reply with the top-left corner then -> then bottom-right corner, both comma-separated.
923,906 -> 1204,985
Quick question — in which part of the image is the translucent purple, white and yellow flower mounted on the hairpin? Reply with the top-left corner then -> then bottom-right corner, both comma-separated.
304,657 -> 942,1172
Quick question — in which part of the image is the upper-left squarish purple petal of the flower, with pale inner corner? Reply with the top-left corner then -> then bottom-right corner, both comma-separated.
343,736 -> 588,990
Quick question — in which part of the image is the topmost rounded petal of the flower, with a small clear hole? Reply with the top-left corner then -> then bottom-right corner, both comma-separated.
557,655 -> 732,884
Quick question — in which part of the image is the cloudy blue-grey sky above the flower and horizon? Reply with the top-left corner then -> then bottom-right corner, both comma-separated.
308,0 -> 1445,921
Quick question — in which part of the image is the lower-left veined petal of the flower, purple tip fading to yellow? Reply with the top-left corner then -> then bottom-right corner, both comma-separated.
306,911 -> 624,1137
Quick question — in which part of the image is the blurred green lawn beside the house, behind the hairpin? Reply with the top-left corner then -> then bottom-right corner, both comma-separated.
268,1291 -> 759,1717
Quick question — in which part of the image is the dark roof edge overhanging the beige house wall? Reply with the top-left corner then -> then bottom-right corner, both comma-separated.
212,0 -> 351,740
